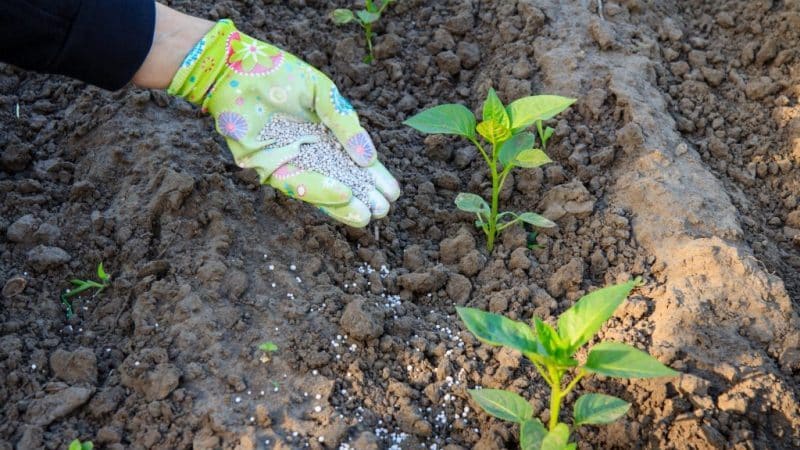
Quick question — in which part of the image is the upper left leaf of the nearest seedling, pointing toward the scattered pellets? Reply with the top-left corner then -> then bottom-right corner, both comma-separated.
456,307 -> 541,353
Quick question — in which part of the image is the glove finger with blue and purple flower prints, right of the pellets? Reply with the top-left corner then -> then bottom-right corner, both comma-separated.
314,74 -> 378,167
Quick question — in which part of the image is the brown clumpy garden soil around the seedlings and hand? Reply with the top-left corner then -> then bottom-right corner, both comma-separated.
0,0 -> 800,450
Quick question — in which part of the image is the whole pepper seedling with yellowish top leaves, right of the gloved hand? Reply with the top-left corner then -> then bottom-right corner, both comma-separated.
404,89 -> 575,251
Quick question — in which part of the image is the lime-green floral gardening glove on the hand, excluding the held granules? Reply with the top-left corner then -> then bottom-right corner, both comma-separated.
168,20 -> 400,227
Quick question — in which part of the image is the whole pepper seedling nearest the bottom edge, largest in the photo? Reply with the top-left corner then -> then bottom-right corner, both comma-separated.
456,279 -> 678,450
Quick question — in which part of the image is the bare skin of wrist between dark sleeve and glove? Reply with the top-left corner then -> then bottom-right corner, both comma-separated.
132,3 -> 214,89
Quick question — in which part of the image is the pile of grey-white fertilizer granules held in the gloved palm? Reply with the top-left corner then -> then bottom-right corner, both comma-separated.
258,116 -> 375,205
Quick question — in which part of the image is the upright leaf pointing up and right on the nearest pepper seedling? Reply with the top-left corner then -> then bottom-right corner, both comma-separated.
558,280 -> 637,354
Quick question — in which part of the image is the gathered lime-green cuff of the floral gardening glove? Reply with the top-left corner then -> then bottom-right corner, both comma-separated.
167,19 -> 237,111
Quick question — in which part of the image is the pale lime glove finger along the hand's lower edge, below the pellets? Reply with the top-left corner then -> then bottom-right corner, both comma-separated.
268,164 -> 353,206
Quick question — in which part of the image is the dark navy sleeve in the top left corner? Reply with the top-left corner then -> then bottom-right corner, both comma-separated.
0,0 -> 155,90
